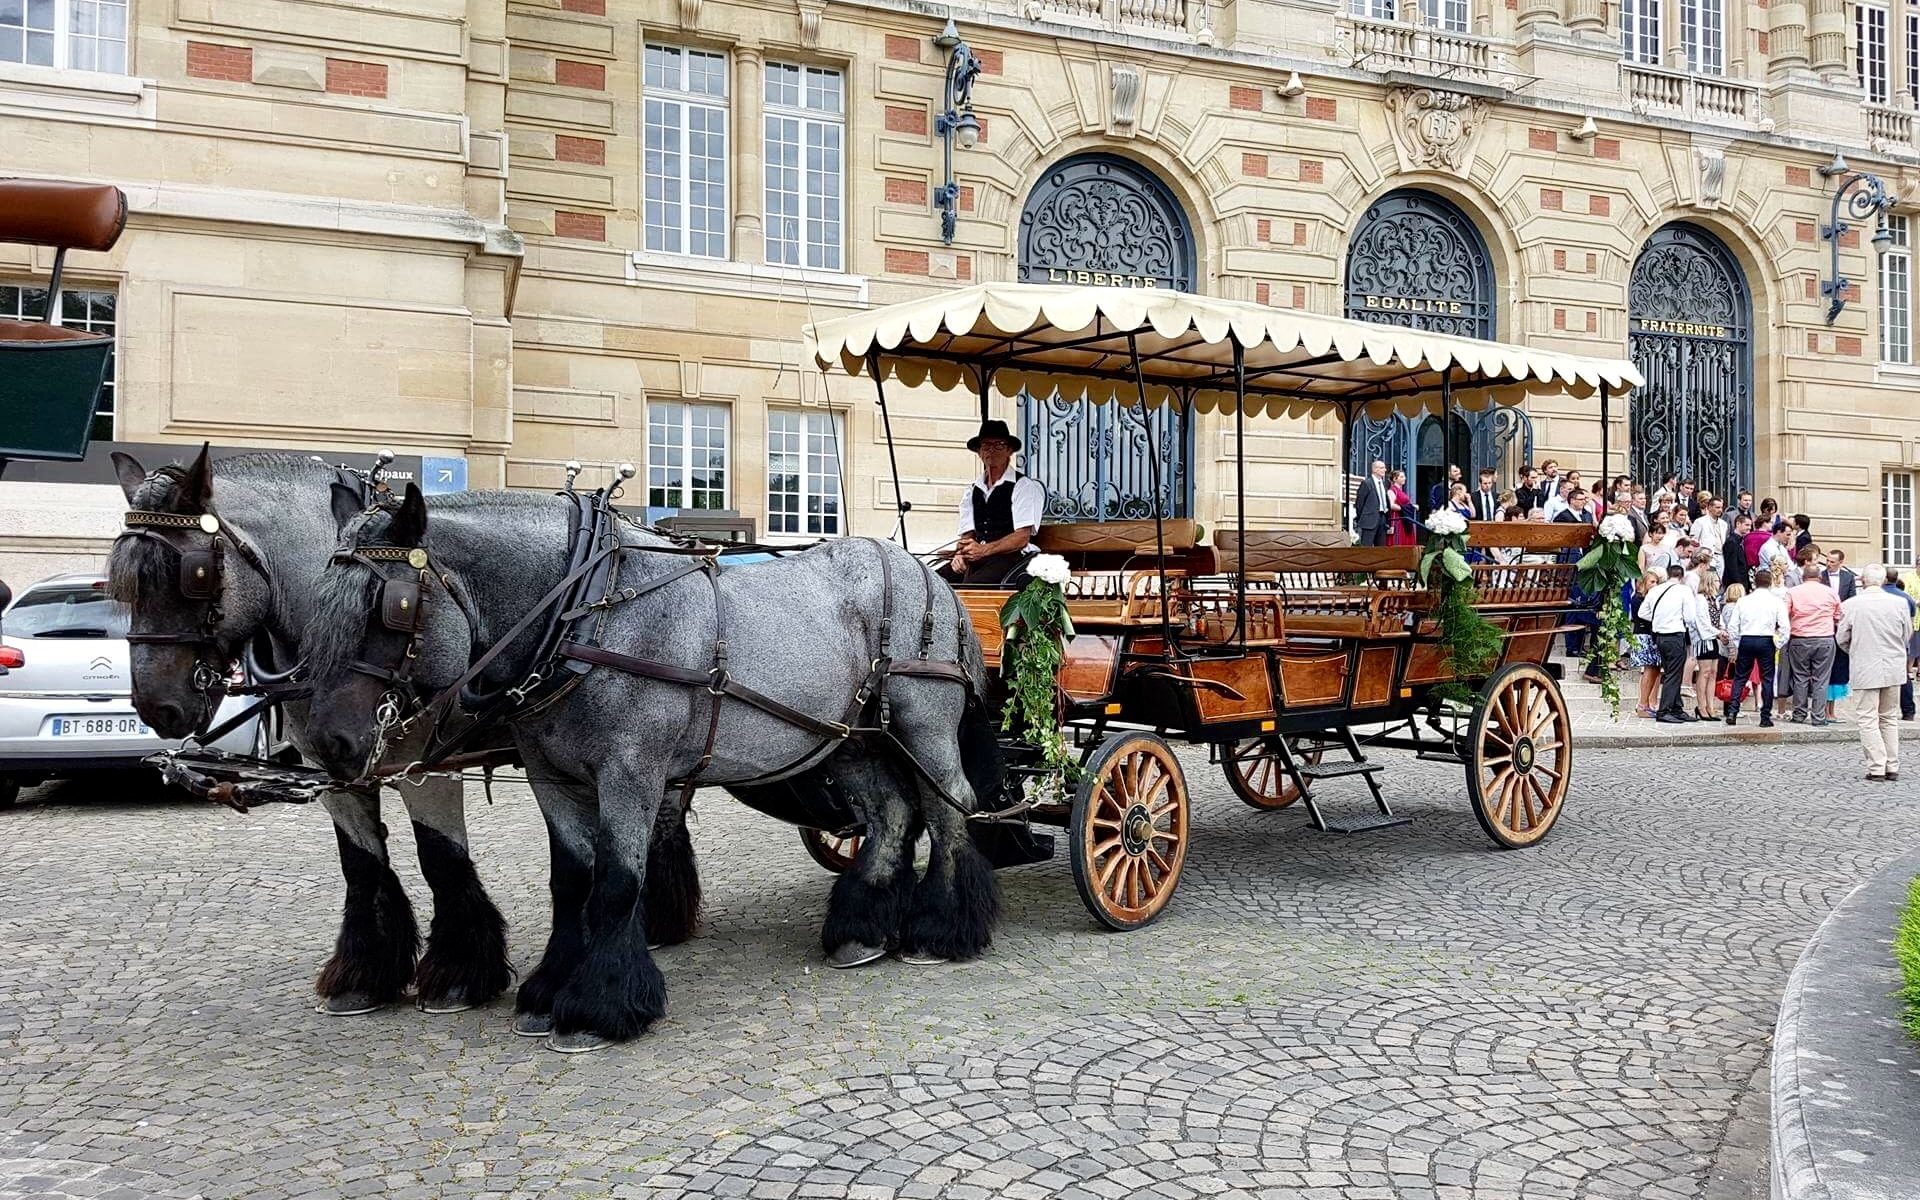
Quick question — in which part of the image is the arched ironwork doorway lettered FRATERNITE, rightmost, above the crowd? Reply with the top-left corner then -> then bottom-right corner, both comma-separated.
1626,221 -> 1753,495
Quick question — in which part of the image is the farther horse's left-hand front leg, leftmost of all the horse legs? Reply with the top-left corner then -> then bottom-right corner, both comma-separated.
313,791 -> 420,1016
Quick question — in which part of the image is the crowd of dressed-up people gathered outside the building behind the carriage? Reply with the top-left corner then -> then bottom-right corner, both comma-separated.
1354,459 -> 1920,780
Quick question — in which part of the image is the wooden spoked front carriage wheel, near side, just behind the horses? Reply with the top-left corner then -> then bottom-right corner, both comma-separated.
1069,732 -> 1187,929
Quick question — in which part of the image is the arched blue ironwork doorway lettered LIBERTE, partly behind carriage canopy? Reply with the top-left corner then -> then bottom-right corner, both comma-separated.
1020,154 -> 1194,520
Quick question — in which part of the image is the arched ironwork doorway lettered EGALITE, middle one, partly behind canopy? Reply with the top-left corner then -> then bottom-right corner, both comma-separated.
1346,188 -> 1534,511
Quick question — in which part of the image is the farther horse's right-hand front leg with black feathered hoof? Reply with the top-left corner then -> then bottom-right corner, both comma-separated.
397,780 -> 513,1014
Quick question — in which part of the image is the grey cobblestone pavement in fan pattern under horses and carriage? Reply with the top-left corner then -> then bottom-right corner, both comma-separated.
0,745 -> 1920,1200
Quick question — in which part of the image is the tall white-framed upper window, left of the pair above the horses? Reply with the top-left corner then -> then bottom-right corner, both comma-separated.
639,40 -> 735,261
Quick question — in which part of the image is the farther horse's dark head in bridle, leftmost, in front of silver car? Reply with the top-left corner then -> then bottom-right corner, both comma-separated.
108,445 -> 271,737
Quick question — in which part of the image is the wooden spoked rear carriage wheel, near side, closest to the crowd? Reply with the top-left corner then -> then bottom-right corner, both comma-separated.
1465,662 -> 1572,851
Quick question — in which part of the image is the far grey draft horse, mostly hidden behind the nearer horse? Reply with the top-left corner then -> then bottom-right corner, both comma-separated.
108,447 -> 526,1016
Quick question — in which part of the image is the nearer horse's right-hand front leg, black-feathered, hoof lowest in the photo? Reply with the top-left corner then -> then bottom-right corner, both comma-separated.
547,756 -> 666,1054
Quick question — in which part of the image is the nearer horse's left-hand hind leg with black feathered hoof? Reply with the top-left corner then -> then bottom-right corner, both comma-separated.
820,747 -> 922,968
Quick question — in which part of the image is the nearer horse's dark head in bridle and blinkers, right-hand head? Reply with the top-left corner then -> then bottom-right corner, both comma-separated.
303,484 -> 472,780
